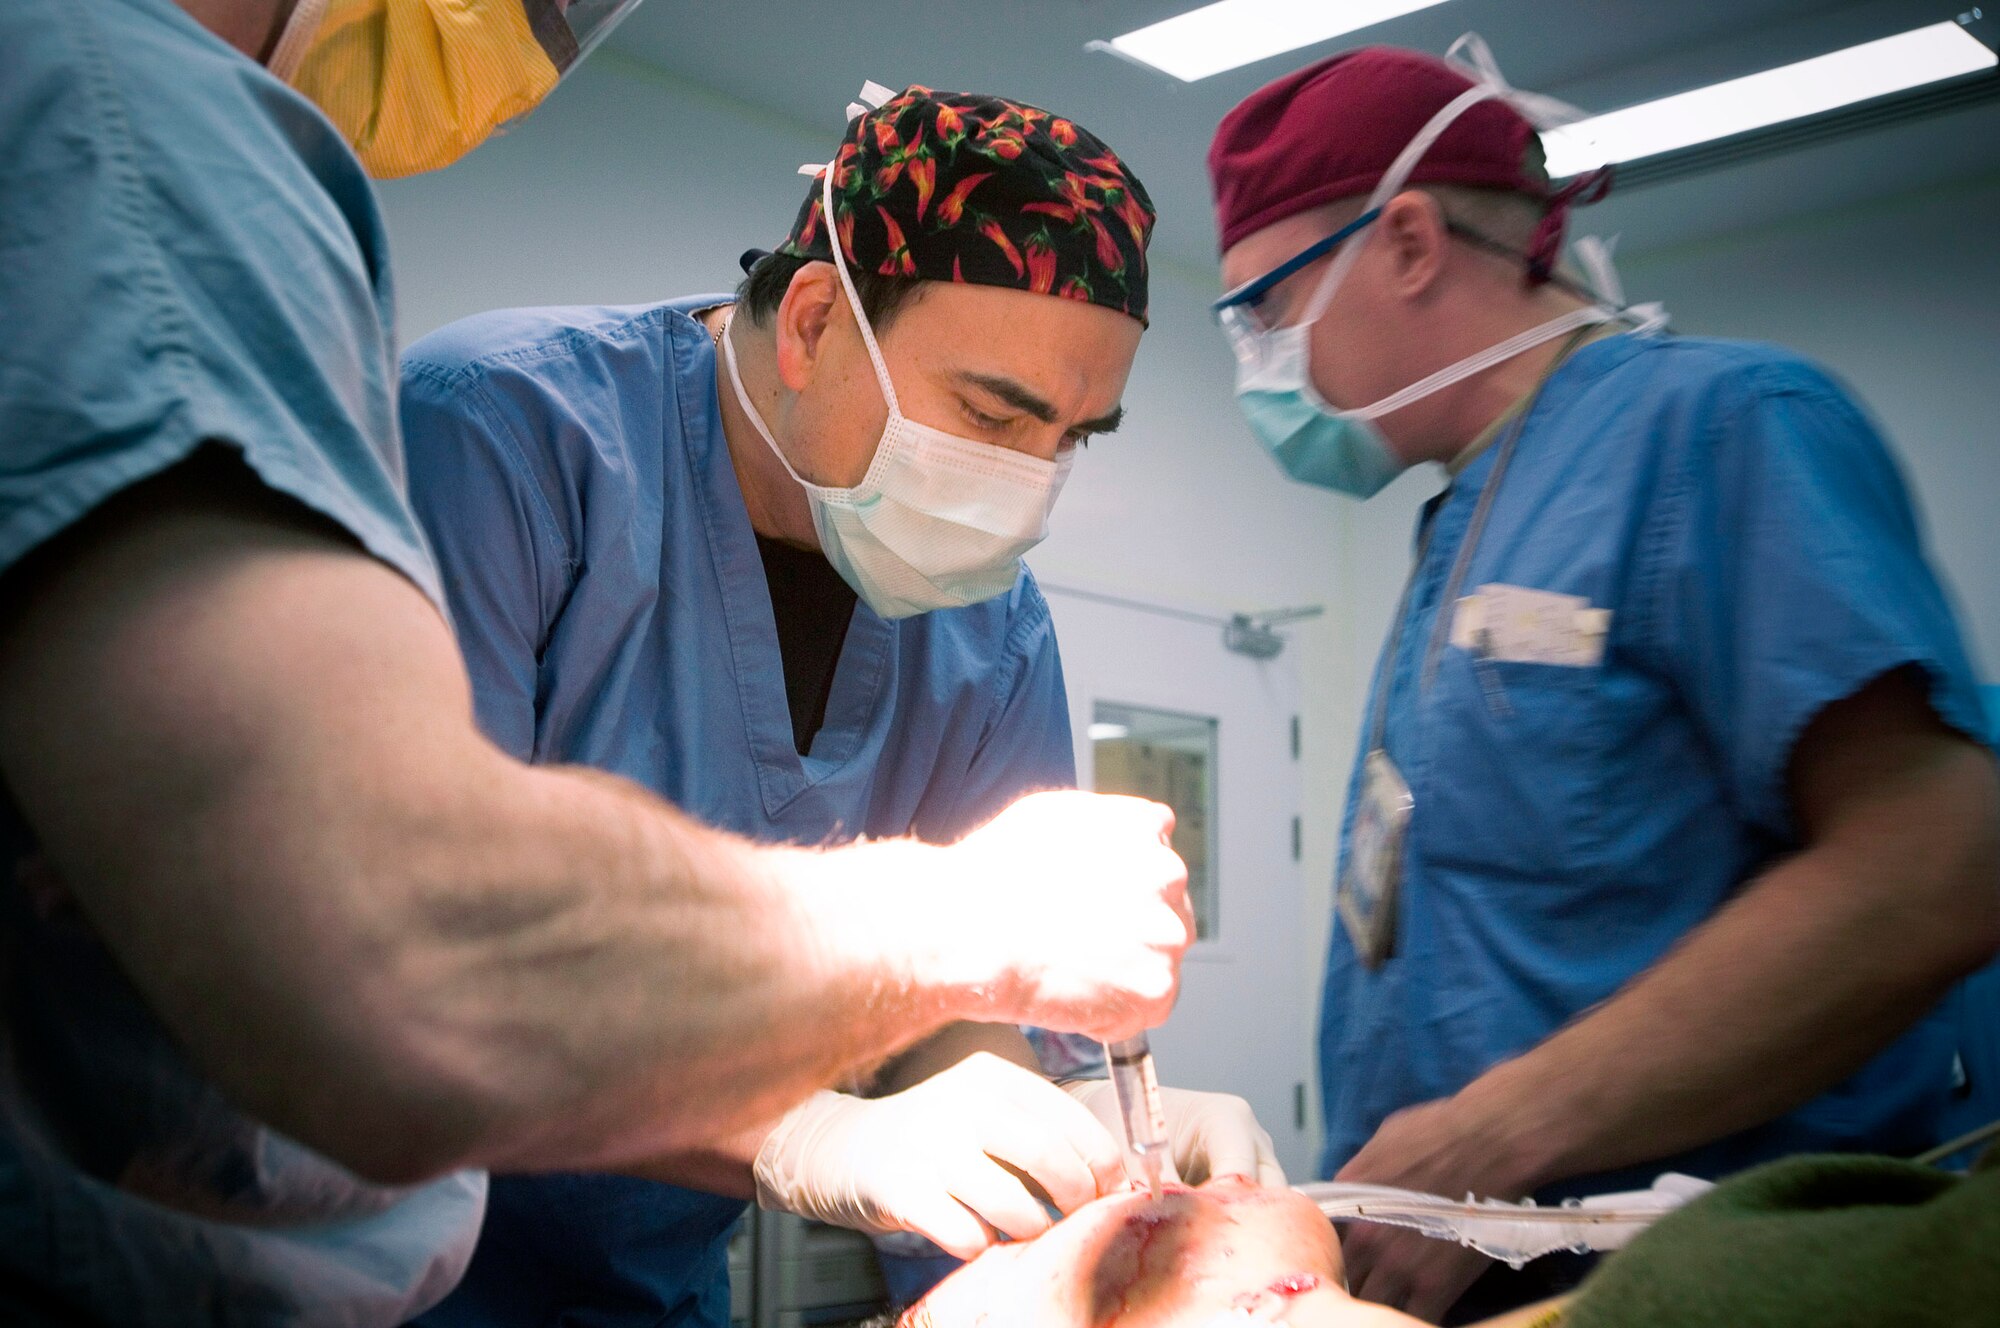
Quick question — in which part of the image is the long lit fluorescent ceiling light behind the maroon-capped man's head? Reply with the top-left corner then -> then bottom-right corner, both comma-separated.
1542,22 -> 1996,180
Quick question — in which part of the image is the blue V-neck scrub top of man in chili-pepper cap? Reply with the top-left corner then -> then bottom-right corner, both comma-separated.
402,296 -> 1076,1328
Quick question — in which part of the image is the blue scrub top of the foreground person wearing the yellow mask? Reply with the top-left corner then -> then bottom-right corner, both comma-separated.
0,0 -> 484,1326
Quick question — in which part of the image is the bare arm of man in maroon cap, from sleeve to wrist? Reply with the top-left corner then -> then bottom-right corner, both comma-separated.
1464,688 -> 2000,1186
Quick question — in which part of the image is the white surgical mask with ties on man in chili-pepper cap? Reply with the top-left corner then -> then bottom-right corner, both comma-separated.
722,154 -> 1076,618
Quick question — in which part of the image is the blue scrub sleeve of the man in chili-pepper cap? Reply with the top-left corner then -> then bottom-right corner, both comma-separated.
402,358 -> 570,760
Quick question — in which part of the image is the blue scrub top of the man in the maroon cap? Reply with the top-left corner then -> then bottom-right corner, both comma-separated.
1320,336 -> 2000,1192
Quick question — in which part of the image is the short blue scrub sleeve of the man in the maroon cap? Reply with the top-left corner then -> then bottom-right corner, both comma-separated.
1656,362 -> 1984,842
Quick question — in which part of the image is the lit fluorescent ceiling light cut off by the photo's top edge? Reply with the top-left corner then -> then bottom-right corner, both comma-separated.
1092,0 -> 1444,82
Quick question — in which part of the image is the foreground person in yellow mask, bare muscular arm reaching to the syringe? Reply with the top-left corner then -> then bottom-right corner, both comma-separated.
0,0 -> 1216,1328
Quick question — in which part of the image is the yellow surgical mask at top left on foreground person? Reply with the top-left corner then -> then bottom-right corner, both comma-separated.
270,0 -> 638,180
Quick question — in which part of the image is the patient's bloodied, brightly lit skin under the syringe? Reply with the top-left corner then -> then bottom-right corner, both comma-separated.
904,1176 -> 1408,1328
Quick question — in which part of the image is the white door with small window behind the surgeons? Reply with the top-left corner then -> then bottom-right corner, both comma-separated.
1042,584 -> 1316,1180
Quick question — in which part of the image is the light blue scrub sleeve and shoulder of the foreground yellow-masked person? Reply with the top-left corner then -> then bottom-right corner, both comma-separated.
0,0 -> 440,602
